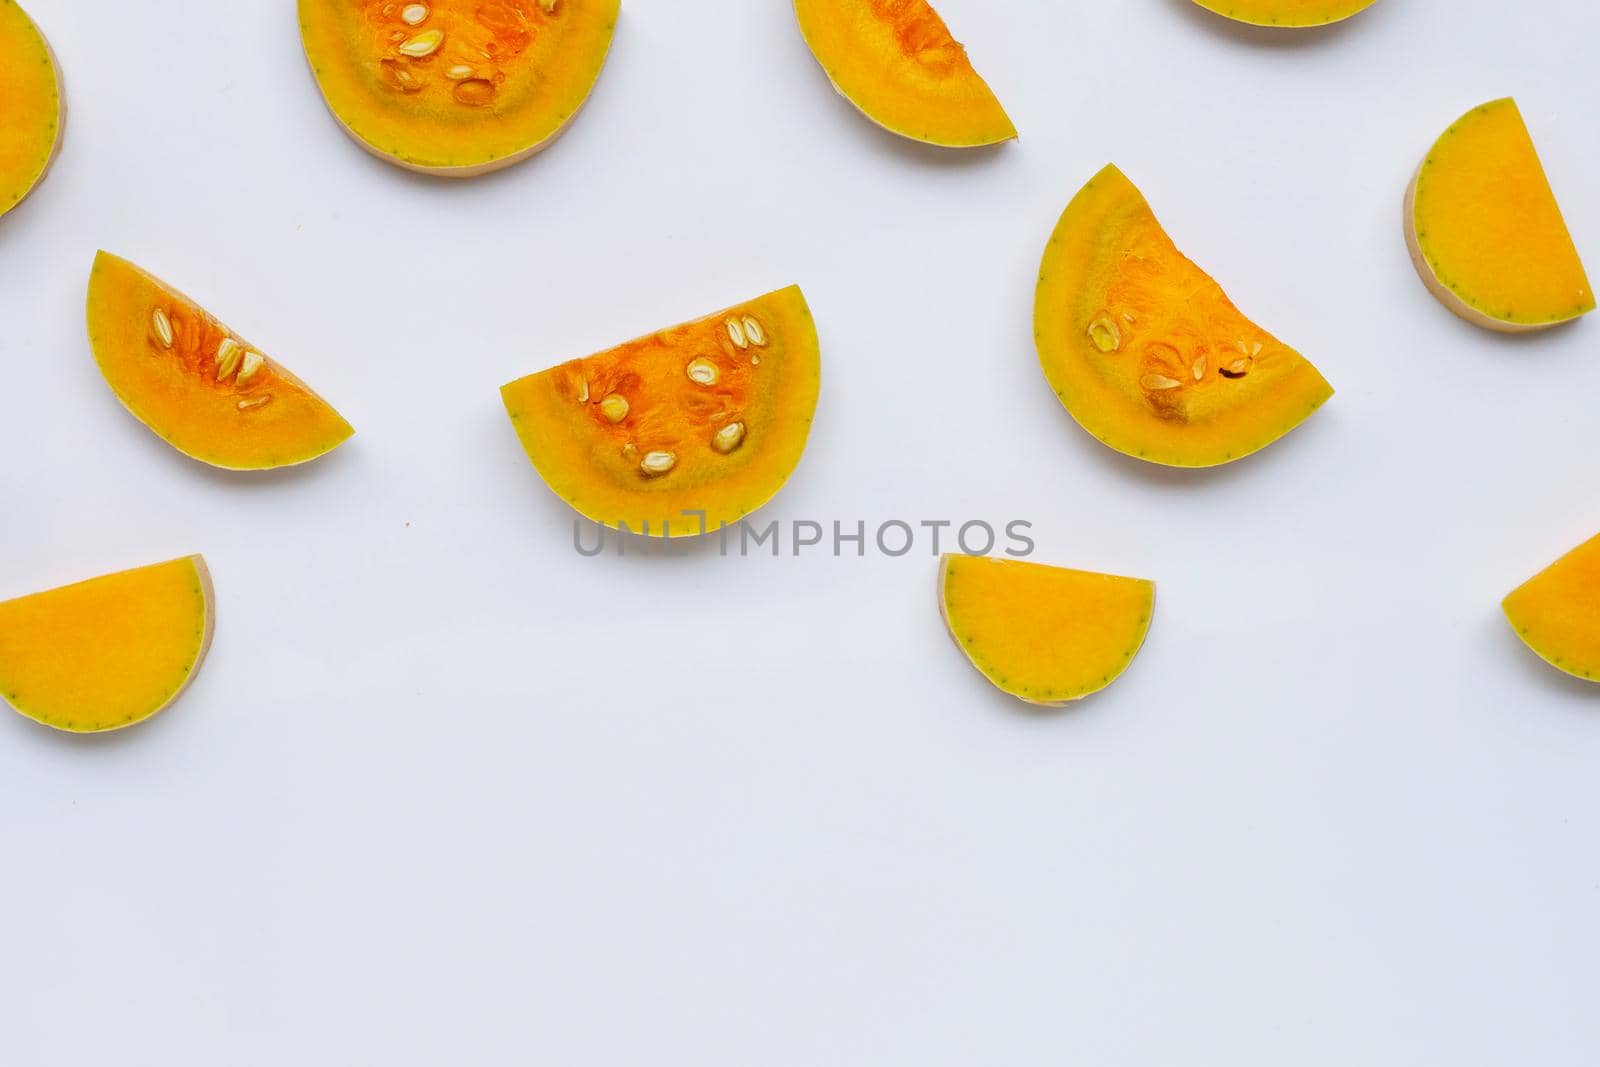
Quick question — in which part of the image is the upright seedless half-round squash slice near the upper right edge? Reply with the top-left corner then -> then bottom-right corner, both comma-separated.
1405,98 -> 1595,333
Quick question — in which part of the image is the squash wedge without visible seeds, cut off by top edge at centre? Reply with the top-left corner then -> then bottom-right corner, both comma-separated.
795,0 -> 1016,147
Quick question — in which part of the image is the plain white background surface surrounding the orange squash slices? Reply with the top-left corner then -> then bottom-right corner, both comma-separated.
0,0 -> 1600,1067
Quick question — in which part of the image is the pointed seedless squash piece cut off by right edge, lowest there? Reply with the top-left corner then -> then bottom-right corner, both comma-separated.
1501,536 -> 1600,681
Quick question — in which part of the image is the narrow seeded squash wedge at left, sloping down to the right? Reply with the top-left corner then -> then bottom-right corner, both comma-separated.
88,251 -> 354,470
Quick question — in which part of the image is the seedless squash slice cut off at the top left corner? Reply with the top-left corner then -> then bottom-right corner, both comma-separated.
0,0 -> 67,214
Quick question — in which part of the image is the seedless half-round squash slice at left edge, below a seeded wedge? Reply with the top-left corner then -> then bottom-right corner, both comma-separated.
0,555 -> 216,733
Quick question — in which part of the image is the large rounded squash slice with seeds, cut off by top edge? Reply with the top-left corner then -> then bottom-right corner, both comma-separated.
299,0 -> 619,178
